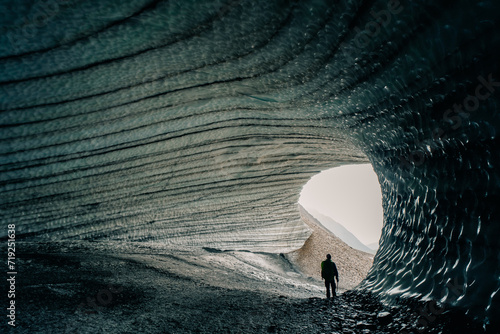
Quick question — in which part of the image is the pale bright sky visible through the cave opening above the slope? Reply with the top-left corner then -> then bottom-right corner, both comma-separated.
299,164 -> 383,244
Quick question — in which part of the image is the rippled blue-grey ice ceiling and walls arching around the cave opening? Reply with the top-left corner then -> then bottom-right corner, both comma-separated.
0,0 -> 500,321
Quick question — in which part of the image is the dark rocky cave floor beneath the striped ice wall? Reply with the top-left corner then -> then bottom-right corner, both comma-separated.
0,242 -> 496,334
